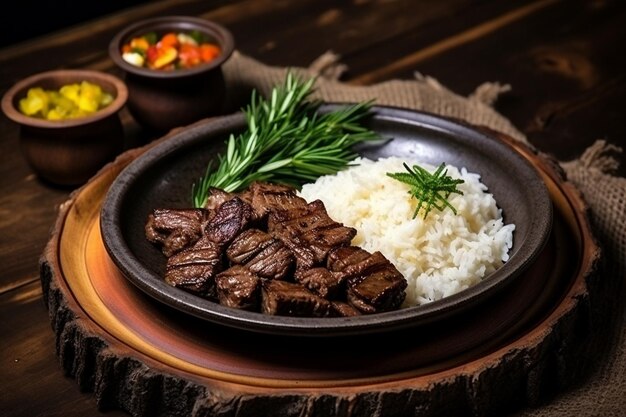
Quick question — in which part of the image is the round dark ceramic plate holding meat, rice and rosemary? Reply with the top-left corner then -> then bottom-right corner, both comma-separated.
101,106 -> 552,336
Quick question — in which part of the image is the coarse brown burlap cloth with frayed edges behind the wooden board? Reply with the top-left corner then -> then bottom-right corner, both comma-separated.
216,52 -> 626,417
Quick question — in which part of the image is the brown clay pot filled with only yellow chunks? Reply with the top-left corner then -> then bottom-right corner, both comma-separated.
2,70 -> 128,186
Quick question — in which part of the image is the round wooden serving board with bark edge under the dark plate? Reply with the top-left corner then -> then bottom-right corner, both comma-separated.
41,124 -> 600,416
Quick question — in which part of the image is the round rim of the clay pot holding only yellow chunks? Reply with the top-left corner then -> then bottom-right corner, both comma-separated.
2,69 -> 128,129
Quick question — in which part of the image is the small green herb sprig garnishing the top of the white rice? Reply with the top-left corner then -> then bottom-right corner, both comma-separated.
387,163 -> 465,219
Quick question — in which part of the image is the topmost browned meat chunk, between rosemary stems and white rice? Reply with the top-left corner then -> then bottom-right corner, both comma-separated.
240,182 -> 307,220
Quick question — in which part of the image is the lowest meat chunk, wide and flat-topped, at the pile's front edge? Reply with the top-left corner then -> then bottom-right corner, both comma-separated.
261,280 -> 331,317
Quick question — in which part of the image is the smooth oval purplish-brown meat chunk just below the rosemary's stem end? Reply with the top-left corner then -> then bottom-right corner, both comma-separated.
204,197 -> 252,246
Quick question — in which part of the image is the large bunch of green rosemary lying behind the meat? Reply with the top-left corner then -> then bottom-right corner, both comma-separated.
192,73 -> 379,207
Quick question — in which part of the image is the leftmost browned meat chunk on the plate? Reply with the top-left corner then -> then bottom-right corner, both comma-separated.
145,209 -> 209,257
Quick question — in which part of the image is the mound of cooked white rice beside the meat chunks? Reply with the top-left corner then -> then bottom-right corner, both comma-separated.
300,157 -> 515,306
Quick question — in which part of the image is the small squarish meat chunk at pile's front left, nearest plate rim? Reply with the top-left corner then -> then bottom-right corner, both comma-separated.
215,265 -> 261,311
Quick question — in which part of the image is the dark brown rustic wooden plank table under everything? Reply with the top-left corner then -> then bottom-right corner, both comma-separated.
0,0 -> 626,417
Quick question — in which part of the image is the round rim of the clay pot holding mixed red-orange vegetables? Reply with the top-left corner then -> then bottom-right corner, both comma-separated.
109,16 -> 235,79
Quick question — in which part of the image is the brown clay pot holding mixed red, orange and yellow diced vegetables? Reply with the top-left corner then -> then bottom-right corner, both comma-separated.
109,16 -> 234,132
